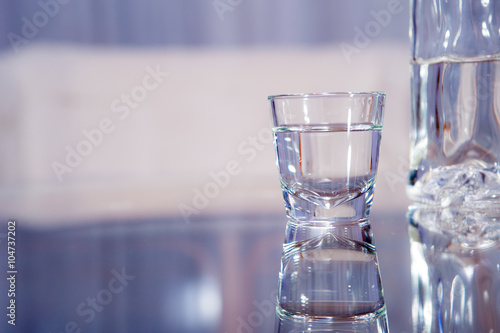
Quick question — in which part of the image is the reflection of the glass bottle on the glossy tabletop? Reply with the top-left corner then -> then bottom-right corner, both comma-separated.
409,206 -> 500,333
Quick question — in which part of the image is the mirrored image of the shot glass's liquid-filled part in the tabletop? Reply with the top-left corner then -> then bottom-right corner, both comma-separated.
278,220 -> 385,320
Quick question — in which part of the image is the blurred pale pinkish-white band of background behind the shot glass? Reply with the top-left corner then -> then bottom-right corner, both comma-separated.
0,43 -> 410,226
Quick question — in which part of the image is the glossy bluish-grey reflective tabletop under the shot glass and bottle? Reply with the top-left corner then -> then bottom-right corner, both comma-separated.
0,210 -> 500,333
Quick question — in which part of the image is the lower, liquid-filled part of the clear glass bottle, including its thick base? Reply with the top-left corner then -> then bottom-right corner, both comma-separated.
408,57 -> 500,206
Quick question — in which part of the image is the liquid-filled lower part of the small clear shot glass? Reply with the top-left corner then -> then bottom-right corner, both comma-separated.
275,124 -> 381,220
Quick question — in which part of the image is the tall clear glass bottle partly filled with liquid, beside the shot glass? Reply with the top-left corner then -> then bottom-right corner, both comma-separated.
408,0 -> 500,206
